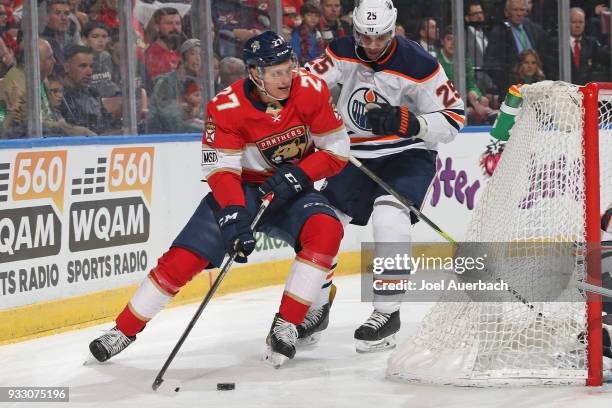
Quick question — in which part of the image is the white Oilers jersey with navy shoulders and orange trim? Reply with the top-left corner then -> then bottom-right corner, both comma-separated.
306,36 -> 465,158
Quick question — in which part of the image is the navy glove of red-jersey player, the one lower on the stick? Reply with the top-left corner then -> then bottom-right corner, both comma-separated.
217,205 -> 255,263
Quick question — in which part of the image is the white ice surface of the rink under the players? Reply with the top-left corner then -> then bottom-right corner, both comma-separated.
0,276 -> 612,408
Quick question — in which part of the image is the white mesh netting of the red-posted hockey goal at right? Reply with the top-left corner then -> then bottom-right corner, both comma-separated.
387,81 -> 612,386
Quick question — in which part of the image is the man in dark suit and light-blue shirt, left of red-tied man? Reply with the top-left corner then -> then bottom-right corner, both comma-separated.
485,0 -> 555,100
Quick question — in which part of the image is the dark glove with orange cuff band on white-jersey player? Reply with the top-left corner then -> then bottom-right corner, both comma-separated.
366,102 -> 421,138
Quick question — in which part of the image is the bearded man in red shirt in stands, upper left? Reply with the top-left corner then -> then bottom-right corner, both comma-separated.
145,7 -> 183,81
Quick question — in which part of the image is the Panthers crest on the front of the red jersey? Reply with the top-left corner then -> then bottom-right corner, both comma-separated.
257,126 -> 308,166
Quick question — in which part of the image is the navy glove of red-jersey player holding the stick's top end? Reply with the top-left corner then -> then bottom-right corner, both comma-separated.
259,164 -> 312,209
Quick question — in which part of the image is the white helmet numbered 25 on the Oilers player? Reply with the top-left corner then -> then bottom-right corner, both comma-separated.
353,0 -> 397,39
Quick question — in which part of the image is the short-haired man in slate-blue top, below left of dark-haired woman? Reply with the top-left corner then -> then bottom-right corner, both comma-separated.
60,45 -> 121,134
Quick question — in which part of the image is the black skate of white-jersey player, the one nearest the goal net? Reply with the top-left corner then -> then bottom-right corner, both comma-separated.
355,310 -> 400,353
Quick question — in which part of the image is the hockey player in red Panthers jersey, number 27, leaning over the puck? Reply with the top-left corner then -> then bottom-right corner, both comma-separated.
89,31 -> 349,366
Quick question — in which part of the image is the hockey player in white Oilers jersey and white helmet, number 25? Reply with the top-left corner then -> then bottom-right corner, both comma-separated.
298,0 -> 465,352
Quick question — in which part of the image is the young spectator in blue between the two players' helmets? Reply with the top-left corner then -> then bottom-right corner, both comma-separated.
291,1 -> 327,65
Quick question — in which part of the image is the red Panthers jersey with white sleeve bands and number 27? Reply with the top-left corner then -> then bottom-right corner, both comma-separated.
202,70 -> 349,207
